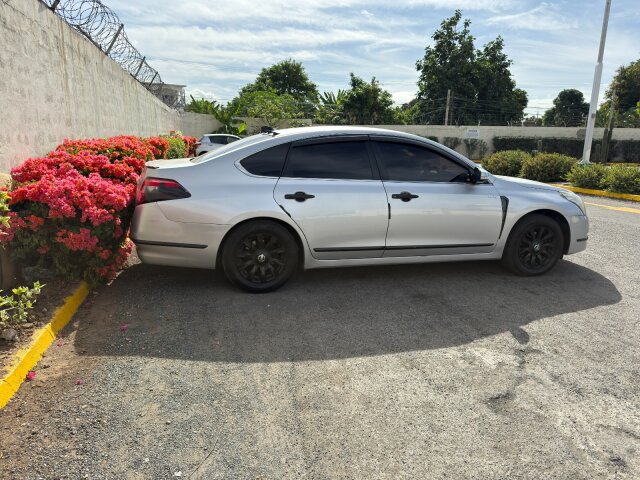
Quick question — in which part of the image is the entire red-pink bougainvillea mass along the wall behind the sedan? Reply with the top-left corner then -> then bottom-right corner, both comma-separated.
0,132 -> 196,283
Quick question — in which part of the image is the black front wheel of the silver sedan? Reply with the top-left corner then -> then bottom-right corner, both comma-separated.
502,214 -> 564,276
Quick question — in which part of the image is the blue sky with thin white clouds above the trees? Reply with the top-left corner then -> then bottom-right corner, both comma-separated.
103,0 -> 640,115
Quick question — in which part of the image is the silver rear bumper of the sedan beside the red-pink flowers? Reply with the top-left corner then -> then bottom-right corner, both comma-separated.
131,203 -> 228,269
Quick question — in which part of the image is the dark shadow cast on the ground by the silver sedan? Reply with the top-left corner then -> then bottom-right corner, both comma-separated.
75,261 -> 621,362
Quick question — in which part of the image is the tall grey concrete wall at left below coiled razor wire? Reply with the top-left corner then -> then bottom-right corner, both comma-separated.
0,0 -> 219,172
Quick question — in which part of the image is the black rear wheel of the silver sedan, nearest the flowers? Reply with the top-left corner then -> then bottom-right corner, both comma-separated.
222,220 -> 298,293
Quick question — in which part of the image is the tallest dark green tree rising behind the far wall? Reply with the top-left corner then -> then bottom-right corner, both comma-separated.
416,10 -> 527,124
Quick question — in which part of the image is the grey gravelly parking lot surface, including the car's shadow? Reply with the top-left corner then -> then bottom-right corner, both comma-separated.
0,198 -> 640,479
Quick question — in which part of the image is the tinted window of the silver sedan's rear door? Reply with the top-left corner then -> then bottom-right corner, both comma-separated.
284,142 -> 373,180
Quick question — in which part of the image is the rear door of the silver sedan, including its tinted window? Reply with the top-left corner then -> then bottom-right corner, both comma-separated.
274,136 -> 388,260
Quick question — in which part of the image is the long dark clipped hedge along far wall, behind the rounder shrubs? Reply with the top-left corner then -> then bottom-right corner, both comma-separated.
493,137 -> 640,163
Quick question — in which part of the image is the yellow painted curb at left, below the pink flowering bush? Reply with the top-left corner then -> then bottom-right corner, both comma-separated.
0,282 -> 89,408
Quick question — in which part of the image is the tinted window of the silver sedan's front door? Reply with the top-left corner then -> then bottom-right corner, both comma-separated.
377,142 -> 469,182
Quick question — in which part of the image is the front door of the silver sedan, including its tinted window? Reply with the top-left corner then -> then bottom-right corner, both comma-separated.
373,139 -> 502,257
